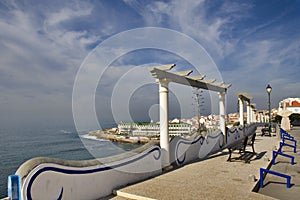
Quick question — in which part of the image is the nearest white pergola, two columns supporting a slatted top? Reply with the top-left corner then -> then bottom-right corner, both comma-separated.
150,64 -> 231,167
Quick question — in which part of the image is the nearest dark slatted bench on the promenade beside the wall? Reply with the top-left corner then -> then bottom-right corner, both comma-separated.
227,133 -> 256,163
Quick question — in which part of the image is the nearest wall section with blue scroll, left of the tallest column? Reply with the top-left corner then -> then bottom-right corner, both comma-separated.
16,144 -> 162,200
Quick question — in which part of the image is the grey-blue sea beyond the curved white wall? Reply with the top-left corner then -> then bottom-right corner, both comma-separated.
0,124 -> 140,198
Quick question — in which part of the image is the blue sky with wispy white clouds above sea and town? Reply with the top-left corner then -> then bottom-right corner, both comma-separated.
0,0 -> 300,129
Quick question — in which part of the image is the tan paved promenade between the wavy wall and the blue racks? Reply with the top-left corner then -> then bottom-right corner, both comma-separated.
113,129 -> 279,200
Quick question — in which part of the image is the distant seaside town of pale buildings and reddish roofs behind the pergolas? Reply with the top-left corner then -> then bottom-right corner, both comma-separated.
88,98 -> 300,143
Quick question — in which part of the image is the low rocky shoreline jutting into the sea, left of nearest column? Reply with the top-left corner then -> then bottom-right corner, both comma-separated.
87,128 -> 159,144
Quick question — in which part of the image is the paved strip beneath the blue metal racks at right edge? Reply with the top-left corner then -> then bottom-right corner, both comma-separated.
259,127 -> 300,200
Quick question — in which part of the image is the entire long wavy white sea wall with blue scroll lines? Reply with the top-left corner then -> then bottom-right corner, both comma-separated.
9,124 -> 258,200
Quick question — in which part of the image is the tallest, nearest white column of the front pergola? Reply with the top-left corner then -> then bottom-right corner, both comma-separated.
159,80 -> 170,167
